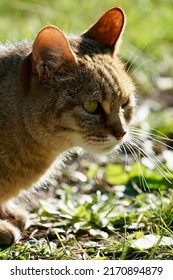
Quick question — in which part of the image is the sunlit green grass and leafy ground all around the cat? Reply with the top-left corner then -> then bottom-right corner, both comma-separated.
0,0 -> 173,260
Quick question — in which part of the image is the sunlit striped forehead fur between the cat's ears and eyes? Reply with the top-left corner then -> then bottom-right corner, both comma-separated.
76,55 -> 133,100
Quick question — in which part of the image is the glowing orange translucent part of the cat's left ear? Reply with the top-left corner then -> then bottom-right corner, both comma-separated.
32,25 -> 76,66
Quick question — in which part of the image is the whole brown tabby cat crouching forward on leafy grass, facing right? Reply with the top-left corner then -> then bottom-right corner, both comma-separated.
0,8 -> 135,246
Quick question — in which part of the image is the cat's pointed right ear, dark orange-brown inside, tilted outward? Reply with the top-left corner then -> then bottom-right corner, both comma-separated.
82,8 -> 125,53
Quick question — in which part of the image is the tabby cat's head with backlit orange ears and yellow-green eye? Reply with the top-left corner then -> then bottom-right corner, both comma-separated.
22,8 -> 135,153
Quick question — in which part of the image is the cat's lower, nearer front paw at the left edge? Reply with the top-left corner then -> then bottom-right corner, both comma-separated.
0,220 -> 20,246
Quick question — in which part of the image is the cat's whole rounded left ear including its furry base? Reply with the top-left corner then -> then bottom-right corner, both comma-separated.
31,25 -> 77,78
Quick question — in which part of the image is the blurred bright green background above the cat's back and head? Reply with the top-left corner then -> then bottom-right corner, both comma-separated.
0,0 -> 173,94
